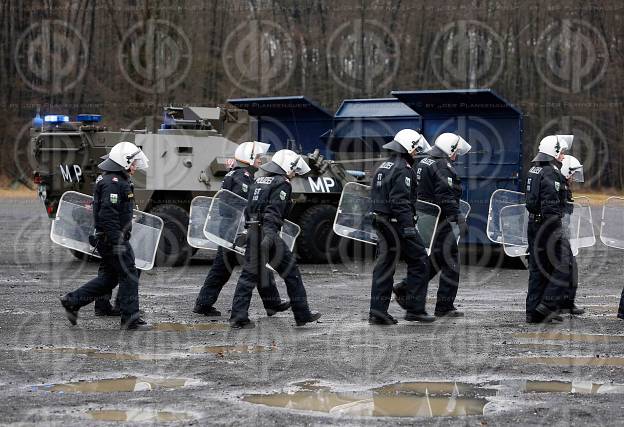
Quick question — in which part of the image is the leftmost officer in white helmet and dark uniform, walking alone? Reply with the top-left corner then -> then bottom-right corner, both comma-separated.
61,141 -> 148,329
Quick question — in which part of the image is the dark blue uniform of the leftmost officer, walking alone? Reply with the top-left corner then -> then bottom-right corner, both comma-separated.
63,172 -> 139,325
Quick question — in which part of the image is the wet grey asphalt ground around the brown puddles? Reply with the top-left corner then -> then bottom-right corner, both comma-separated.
0,199 -> 624,426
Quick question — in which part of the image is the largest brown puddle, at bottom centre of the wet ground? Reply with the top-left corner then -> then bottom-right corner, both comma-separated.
243,383 -> 495,417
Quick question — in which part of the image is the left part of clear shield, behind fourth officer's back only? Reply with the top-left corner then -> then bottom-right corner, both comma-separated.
334,182 -> 377,244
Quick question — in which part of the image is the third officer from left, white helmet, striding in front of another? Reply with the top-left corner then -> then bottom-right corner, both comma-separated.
230,150 -> 321,329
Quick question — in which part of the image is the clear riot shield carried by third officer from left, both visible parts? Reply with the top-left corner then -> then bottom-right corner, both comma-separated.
204,190 -> 301,255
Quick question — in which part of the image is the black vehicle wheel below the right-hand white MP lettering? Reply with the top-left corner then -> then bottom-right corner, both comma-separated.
297,205 -> 340,263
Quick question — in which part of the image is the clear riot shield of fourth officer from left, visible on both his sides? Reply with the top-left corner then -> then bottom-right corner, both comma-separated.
333,182 -> 440,254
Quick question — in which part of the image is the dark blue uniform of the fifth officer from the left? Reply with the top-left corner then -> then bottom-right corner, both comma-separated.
416,147 -> 465,314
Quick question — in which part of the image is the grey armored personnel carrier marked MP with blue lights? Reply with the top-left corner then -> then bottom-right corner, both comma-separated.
31,107 -> 355,265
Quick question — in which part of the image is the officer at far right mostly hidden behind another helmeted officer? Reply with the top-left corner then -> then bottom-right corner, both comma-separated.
561,154 -> 585,316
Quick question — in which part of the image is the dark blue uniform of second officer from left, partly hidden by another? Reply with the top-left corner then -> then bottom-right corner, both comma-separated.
194,167 -> 281,313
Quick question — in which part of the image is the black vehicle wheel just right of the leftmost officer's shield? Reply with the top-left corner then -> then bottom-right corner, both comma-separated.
149,204 -> 193,266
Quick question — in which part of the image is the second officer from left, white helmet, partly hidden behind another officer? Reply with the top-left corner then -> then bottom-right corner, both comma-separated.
193,141 -> 290,316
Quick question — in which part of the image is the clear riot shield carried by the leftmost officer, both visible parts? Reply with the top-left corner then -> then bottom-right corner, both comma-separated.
50,191 -> 163,270
